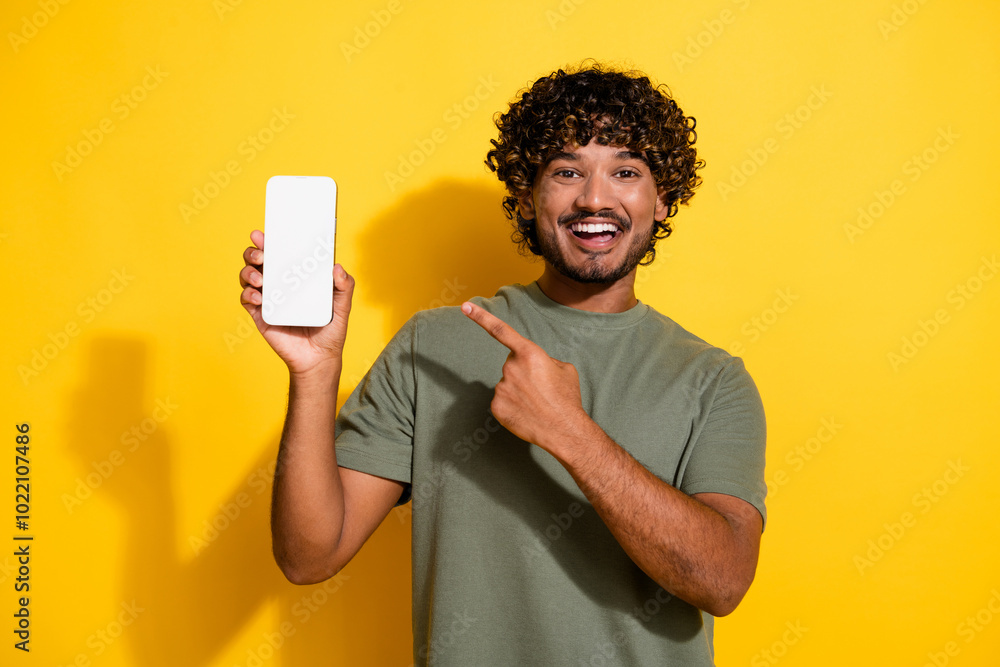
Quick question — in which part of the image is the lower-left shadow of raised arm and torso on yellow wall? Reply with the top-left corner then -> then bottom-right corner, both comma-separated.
65,337 -> 412,667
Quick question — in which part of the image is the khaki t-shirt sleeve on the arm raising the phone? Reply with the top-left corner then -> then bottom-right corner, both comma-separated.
334,316 -> 417,506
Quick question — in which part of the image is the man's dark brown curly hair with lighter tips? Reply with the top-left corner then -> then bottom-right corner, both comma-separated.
486,62 -> 705,266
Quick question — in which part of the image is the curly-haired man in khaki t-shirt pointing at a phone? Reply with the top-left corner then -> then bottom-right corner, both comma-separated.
240,65 -> 765,666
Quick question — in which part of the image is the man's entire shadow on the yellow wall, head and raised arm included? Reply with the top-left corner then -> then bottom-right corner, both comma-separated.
61,181 -> 541,667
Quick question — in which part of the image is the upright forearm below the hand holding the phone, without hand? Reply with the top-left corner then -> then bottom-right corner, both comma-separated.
271,364 -> 344,583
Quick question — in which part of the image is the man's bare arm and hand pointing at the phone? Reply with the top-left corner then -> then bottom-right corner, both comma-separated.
462,303 -> 762,616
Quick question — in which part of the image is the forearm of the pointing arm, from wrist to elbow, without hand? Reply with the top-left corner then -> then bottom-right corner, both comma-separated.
555,421 -> 757,616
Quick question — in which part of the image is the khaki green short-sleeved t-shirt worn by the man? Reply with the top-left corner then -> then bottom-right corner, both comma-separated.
336,283 -> 766,667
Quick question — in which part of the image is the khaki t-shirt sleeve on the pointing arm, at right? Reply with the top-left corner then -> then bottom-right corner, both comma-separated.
680,357 -> 767,523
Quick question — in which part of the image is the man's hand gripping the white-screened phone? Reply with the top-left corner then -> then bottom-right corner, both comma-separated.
240,229 -> 354,375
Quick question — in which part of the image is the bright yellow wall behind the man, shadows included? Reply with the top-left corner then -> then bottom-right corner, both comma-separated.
0,0 -> 1000,667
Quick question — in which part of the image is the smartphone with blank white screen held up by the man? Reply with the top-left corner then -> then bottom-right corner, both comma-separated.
261,176 -> 337,327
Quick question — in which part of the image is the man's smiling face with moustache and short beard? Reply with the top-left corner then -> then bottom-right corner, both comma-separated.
518,141 -> 668,284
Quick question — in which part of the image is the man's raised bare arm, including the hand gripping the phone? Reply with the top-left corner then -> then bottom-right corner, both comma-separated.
239,230 -> 404,584
